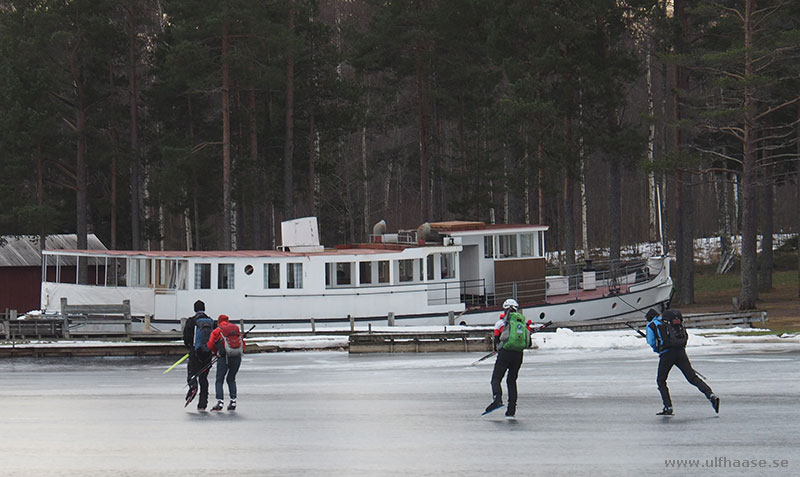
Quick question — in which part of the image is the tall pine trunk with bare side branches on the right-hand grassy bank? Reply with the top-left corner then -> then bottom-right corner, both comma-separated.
739,0 -> 758,310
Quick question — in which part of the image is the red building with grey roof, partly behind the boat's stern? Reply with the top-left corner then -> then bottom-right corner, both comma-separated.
0,234 -> 107,315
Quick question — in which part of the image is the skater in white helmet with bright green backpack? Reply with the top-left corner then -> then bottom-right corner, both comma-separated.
484,299 -> 531,418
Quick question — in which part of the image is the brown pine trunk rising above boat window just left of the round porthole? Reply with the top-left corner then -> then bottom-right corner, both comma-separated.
221,22 -> 233,250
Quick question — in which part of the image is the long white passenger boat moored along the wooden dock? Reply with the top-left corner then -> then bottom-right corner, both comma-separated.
41,217 -> 672,328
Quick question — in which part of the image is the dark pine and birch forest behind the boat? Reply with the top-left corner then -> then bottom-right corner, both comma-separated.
0,0 -> 800,309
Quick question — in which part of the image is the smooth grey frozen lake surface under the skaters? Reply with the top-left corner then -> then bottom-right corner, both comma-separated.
0,338 -> 800,477
